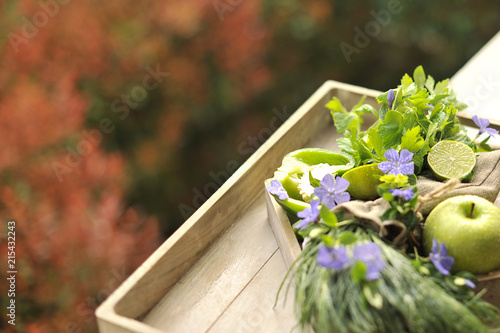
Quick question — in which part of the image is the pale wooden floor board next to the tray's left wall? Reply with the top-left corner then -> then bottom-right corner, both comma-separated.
143,197 -> 278,332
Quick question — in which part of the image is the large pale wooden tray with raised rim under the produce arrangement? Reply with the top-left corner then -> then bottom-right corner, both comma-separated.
96,81 -> 500,333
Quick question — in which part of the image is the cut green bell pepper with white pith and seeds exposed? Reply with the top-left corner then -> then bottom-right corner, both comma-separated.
274,148 -> 354,200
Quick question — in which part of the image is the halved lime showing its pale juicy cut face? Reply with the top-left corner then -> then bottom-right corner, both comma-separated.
427,140 -> 476,180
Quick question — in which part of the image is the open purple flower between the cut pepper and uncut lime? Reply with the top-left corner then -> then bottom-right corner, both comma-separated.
314,173 -> 351,209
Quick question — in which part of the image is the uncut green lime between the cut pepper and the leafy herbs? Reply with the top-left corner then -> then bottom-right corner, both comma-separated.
342,164 -> 384,200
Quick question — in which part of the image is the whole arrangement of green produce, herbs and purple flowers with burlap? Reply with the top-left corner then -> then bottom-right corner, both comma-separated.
266,67 -> 500,332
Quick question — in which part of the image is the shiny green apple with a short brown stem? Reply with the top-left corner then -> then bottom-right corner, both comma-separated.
423,195 -> 500,274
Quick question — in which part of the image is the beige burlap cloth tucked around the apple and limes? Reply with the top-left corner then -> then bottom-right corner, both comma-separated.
335,150 -> 500,247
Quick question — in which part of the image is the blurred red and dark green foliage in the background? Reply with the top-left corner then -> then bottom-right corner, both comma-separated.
0,0 -> 500,332
